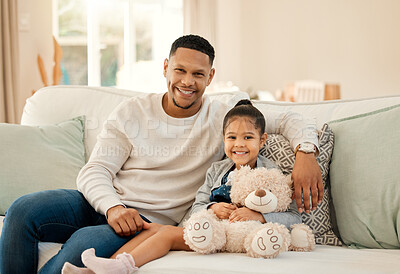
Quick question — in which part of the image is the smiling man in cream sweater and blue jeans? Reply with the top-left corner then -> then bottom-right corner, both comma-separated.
0,35 -> 323,273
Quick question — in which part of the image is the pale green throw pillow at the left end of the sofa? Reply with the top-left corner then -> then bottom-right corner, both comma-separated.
0,116 -> 85,215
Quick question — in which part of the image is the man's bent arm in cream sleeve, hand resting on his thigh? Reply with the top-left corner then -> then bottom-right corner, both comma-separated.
77,103 -> 147,236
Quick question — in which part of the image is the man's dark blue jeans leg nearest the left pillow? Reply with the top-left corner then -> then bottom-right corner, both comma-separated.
0,190 -> 131,274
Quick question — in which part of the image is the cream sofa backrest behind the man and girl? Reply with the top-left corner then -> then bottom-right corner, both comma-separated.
21,86 -> 400,158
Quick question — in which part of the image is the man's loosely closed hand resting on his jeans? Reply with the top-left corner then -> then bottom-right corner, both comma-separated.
107,205 -> 149,236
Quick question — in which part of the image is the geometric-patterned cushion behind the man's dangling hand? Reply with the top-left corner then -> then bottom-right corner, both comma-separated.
260,124 -> 342,246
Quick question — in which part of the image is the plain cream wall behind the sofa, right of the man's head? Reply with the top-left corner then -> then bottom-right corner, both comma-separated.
217,0 -> 400,99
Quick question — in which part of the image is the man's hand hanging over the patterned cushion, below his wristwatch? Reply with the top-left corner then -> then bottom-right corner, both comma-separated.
292,151 -> 324,213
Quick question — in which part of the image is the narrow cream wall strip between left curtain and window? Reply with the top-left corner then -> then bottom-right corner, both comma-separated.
17,0 -> 54,120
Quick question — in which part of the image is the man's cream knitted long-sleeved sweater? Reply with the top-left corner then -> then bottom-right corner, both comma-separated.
77,94 -> 317,225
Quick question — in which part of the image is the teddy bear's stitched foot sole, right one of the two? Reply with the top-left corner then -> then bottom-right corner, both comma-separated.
246,224 -> 290,259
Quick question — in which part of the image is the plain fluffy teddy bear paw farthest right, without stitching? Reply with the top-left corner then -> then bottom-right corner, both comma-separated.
289,224 -> 315,252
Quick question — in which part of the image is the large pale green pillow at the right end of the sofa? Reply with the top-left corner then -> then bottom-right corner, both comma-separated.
329,105 -> 400,248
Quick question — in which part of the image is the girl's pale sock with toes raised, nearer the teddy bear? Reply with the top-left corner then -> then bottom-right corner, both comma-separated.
81,248 -> 138,274
